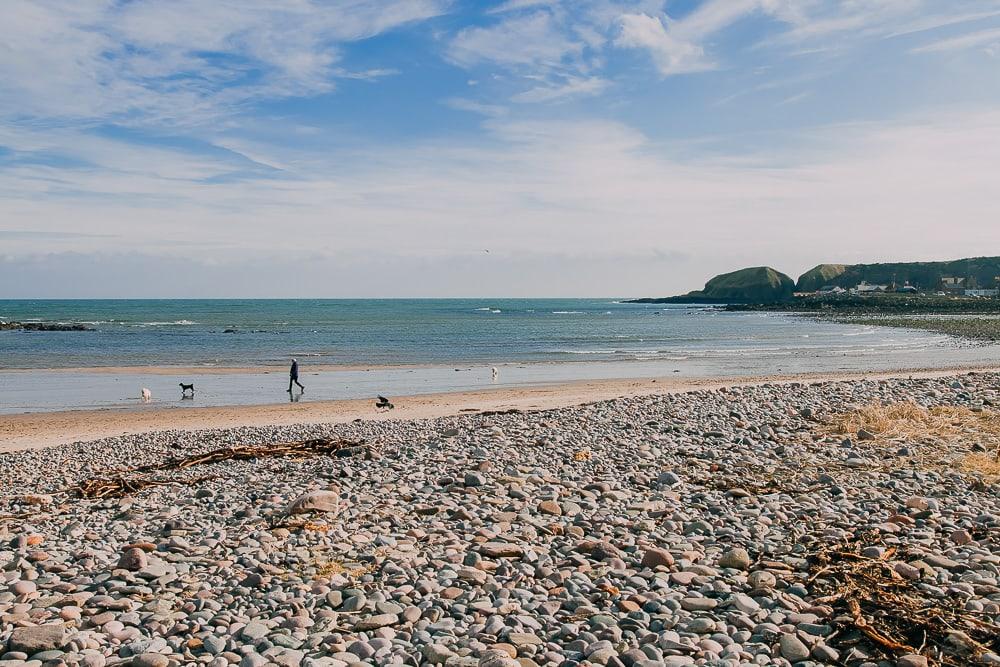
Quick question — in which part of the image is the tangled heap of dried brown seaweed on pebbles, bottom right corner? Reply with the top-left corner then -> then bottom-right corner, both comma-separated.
806,534 -> 1000,667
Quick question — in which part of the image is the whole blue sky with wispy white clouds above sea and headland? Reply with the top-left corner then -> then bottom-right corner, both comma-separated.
0,0 -> 1000,298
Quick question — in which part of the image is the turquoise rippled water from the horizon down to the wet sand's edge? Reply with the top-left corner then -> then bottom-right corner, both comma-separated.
0,299 -> 960,369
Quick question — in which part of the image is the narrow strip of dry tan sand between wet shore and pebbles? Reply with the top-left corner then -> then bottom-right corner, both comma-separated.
0,366 -> 995,452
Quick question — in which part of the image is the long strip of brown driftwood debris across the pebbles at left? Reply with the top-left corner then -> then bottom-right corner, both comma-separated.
72,438 -> 370,499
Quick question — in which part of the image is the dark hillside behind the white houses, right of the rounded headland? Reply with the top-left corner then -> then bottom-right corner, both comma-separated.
797,257 -> 1000,292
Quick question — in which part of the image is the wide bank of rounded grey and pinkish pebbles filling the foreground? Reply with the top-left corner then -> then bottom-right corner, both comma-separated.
0,375 -> 1000,667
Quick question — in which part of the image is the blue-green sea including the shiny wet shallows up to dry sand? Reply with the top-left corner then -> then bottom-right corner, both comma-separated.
0,299 -> 1000,414
